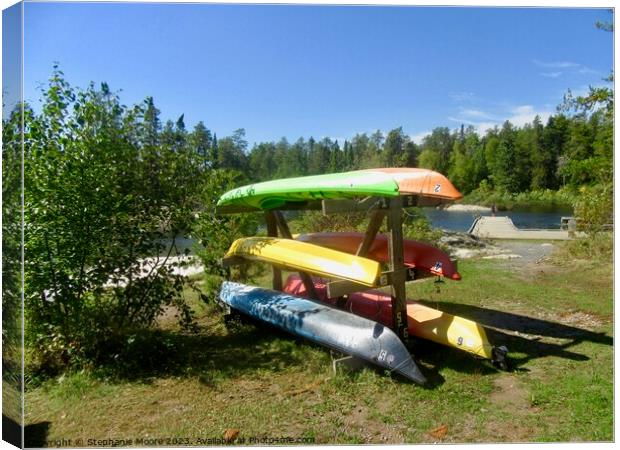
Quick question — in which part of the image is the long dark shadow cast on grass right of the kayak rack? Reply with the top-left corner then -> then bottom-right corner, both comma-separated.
420,301 -> 613,371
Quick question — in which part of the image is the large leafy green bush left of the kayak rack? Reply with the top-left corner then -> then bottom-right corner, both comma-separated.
24,70 -> 204,370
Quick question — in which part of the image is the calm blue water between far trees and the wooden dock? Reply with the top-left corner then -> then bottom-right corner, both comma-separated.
423,208 -> 572,231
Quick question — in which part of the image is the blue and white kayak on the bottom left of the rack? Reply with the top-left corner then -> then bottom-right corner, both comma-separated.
220,281 -> 426,384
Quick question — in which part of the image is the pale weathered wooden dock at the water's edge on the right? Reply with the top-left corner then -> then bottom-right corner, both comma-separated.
468,216 -> 580,240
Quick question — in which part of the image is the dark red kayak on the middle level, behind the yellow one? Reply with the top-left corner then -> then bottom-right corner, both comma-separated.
295,232 -> 461,280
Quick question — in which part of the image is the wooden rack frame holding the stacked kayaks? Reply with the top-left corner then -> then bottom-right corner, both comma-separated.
216,195 -> 432,345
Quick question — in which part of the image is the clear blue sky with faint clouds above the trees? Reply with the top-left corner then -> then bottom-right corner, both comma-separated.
24,3 -> 613,143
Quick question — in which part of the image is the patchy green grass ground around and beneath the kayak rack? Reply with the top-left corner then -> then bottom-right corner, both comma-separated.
26,243 -> 613,446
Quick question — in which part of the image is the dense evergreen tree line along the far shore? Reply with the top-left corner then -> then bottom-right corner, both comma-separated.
197,109 -> 613,197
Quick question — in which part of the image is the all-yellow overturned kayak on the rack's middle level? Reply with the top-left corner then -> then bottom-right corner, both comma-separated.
224,237 -> 381,287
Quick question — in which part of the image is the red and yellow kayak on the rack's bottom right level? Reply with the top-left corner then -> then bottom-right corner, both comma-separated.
284,275 -> 494,360
